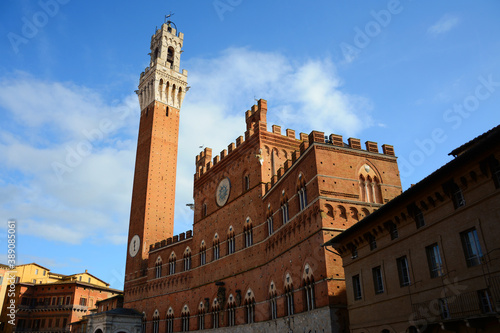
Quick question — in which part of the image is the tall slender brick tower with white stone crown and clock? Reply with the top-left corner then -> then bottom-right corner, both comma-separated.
125,21 -> 187,281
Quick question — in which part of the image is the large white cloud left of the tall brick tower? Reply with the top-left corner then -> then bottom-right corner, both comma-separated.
0,73 -> 138,244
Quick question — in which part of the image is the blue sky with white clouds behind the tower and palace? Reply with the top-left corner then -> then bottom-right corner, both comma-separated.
0,0 -> 500,288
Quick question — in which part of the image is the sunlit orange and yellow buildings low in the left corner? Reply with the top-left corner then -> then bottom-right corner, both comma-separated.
1,263 -> 121,332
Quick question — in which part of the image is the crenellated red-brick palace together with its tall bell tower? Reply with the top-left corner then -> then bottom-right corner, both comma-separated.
124,22 -> 401,333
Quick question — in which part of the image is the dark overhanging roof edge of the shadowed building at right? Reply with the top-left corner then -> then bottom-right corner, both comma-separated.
322,125 -> 500,247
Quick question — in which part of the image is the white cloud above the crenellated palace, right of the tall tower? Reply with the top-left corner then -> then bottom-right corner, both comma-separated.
176,48 -> 374,228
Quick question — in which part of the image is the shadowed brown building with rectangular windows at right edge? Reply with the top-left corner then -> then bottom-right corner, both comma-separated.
325,126 -> 500,333
